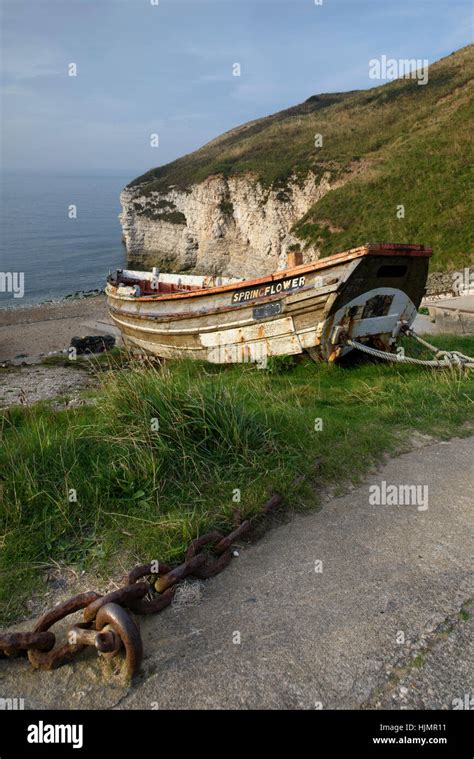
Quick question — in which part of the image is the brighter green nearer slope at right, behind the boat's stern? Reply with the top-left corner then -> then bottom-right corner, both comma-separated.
294,78 -> 474,271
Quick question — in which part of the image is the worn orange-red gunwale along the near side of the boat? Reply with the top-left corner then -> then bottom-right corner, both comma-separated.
106,243 -> 433,303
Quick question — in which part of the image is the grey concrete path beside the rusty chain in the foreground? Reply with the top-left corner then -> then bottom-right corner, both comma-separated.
0,438 -> 474,709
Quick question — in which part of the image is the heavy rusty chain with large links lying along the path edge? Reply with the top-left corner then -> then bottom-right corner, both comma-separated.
0,495 -> 283,677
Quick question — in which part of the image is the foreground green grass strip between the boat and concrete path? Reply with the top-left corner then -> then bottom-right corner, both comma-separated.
0,337 -> 474,623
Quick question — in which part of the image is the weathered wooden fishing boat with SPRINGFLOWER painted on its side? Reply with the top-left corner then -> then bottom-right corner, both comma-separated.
106,243 -> 432,363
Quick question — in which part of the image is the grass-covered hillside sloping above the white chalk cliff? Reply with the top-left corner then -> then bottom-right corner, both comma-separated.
131,46 -> 474,269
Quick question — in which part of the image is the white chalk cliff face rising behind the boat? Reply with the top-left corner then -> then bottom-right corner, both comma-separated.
120,173 -> 331,277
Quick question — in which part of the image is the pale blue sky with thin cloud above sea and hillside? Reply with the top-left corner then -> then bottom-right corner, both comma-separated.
0,0 -> 472,177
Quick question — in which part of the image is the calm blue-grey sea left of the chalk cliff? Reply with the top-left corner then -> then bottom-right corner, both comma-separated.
0,172 -> 131,308
